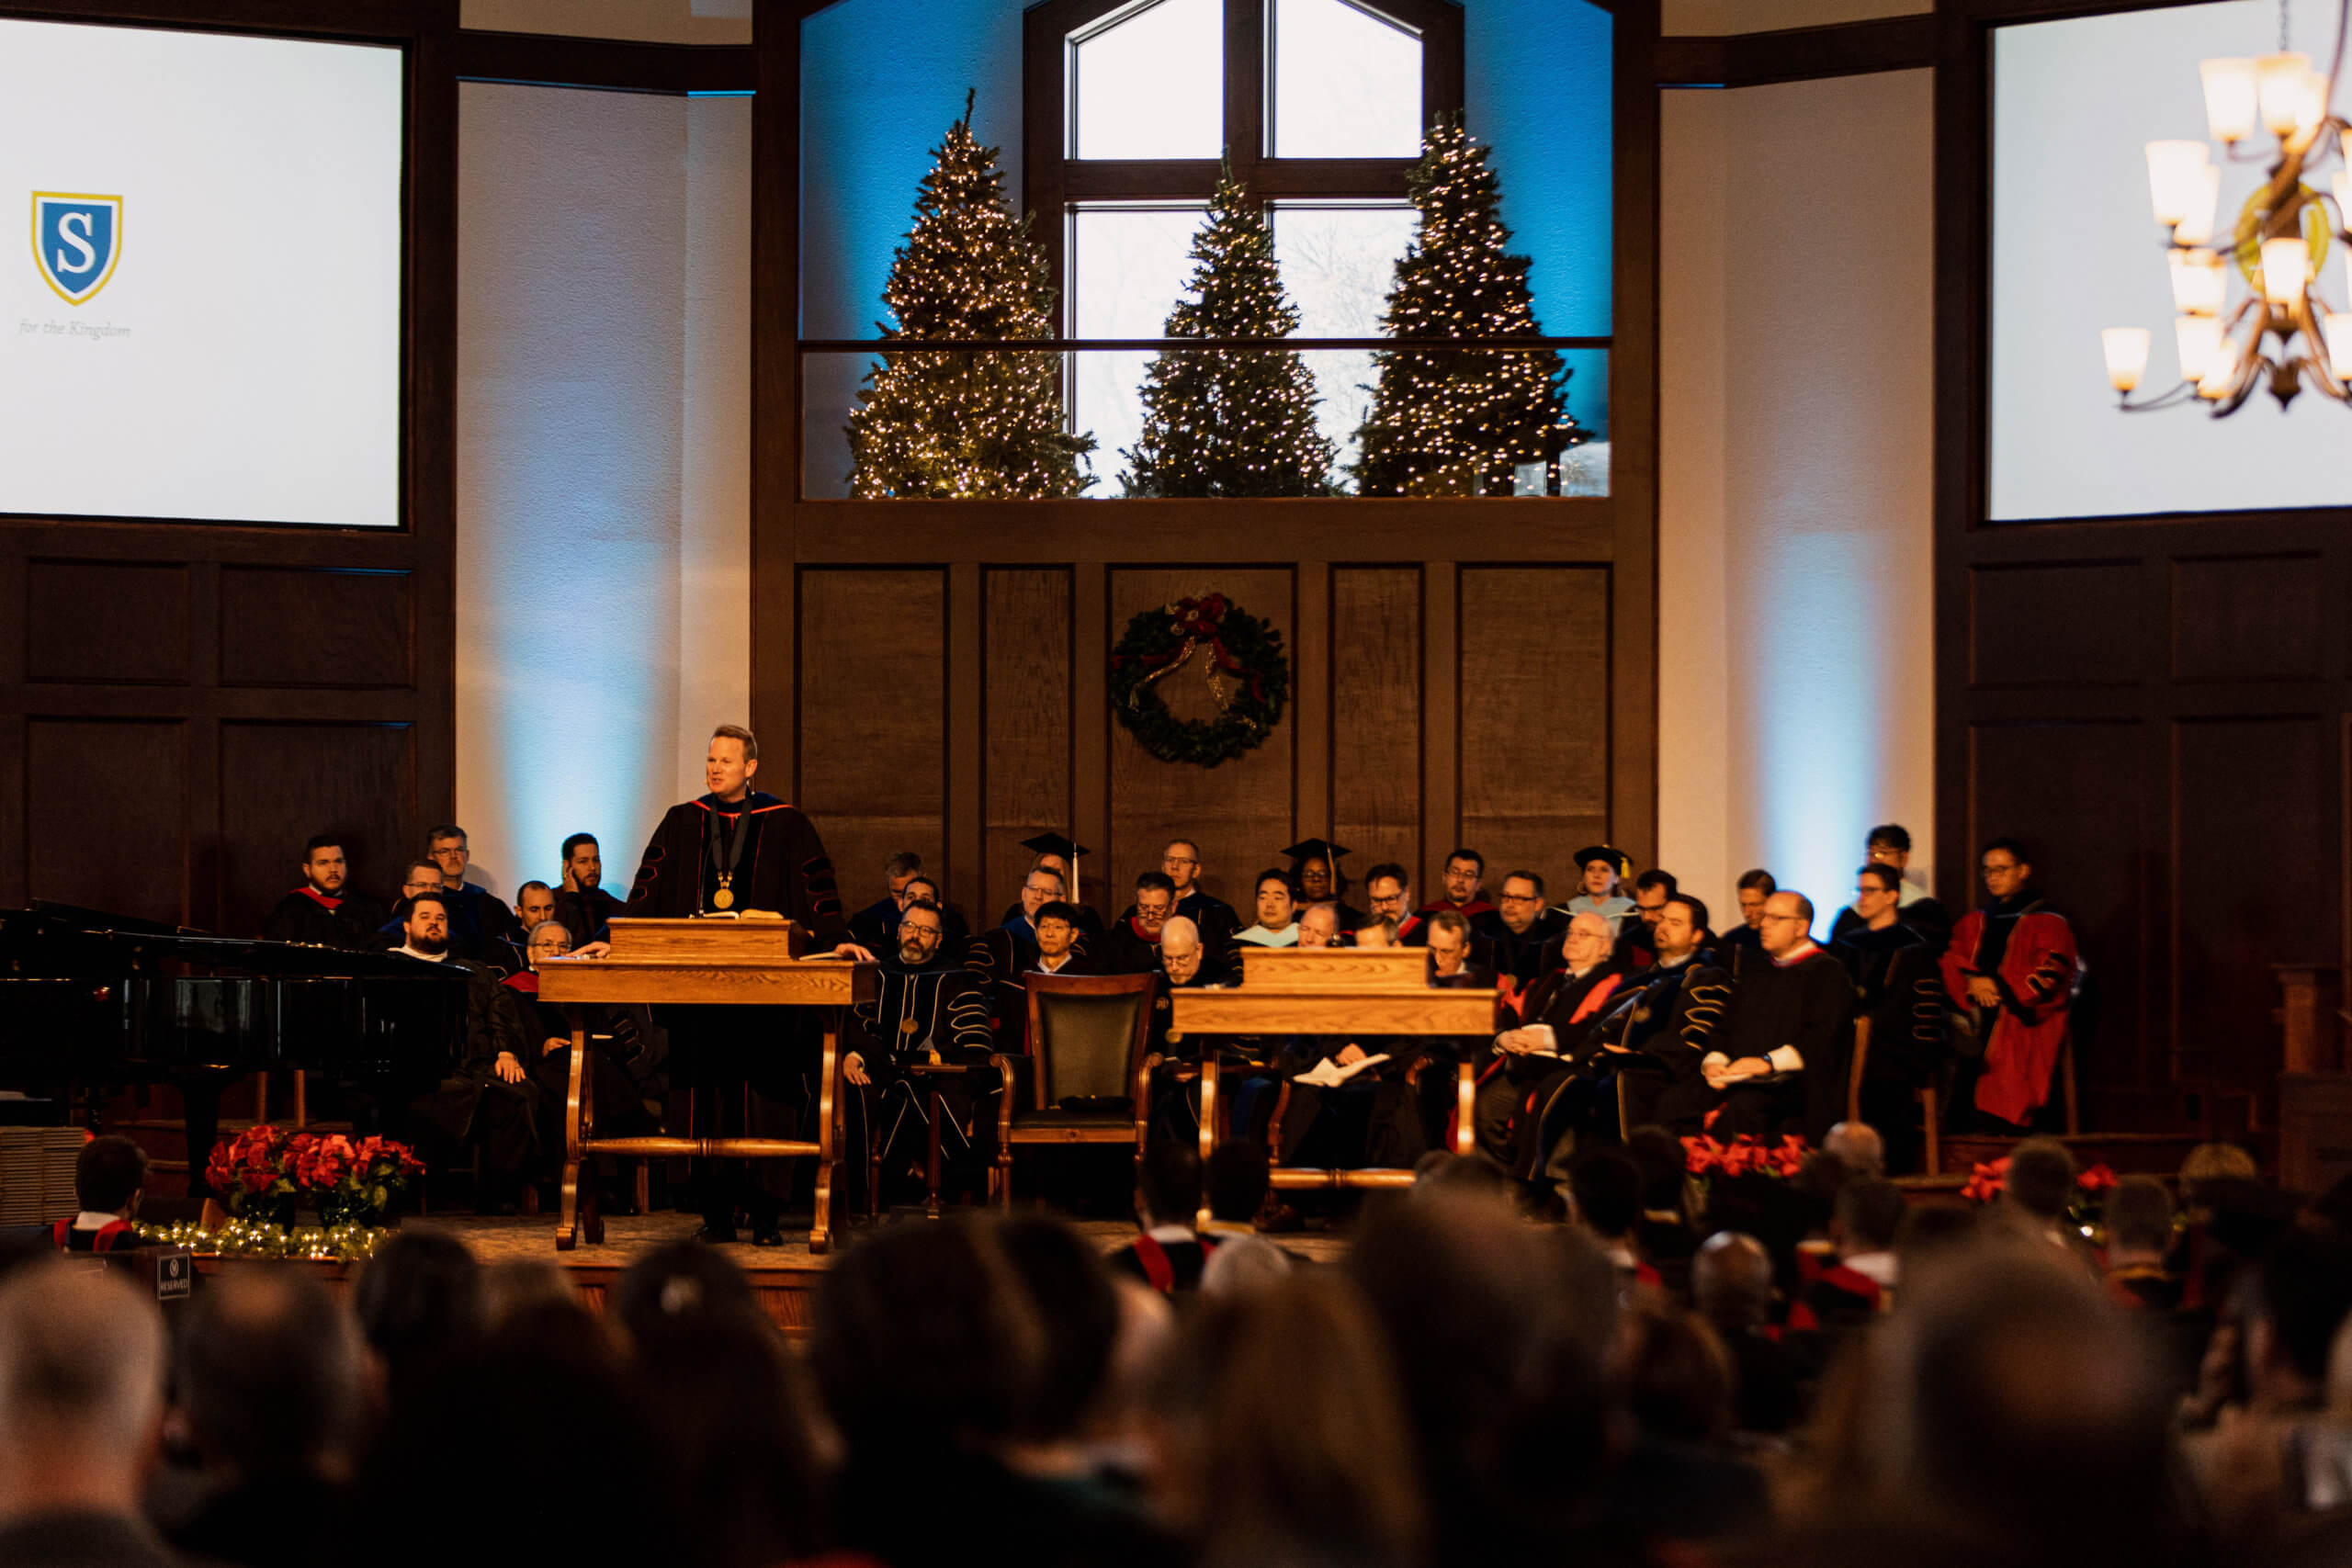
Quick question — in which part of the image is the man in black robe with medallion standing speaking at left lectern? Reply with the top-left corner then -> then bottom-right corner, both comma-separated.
621,724 -> 873,1246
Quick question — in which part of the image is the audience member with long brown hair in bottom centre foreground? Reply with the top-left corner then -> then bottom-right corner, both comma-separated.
1159,1272 -> 1430,1568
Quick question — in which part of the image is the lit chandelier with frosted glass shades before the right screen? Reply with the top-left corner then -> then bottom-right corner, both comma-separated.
2100,0 -> 2352,419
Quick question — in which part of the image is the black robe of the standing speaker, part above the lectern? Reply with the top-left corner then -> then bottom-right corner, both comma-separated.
626,790 -> 849,952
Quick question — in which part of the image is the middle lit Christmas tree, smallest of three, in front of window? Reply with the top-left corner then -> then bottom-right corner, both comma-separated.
1120,163 -> 1336,496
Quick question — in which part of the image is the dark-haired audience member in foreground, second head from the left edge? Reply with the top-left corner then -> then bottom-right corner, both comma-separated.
169,1269 -> 367,1568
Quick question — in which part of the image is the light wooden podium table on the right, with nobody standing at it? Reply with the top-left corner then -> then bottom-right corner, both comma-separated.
1169,947 -> 1496,1190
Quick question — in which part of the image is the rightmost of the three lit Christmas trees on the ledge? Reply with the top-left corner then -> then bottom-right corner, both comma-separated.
1350,113 -> 1578,496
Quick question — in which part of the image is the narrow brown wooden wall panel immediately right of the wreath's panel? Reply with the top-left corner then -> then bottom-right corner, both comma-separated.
1329,567 -> 1420,888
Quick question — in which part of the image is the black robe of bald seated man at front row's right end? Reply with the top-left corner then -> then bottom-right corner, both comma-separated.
1693,947 -> 1853,1143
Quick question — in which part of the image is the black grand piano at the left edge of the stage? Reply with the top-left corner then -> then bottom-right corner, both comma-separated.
0,903 -> 466,1109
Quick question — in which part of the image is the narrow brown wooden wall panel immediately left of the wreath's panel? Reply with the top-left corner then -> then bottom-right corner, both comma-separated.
983,567 -> 1077,931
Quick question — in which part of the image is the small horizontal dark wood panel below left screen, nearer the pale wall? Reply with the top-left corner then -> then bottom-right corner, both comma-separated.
219,567 -> 416,689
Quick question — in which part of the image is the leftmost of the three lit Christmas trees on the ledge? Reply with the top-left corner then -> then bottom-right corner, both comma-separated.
849,96 -> 1093,501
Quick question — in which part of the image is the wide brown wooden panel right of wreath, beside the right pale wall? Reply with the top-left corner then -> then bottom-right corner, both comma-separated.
1432,567 -> 1611,898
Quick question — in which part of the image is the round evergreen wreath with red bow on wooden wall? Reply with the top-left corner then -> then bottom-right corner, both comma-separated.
1110,592 -> 1291,769
